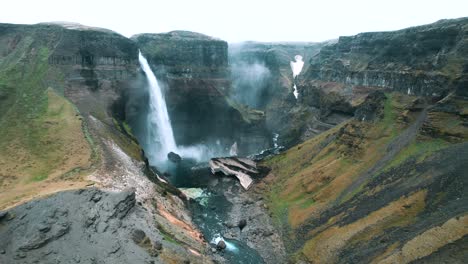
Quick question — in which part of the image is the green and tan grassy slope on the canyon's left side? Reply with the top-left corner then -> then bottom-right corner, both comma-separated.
0,31 -> 92,208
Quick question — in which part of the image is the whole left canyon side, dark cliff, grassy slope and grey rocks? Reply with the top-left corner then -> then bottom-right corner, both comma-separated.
0,24 -> 209,263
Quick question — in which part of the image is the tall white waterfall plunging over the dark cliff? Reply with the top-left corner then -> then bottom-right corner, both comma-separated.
138,52 -> 177,164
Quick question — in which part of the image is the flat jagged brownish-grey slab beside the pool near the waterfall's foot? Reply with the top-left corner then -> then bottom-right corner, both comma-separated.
210,158 -> 260,190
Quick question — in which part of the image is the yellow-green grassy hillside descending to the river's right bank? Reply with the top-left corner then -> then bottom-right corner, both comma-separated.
263,94 -> 467,263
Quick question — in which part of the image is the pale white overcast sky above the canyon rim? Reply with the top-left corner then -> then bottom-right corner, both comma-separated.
0,0 -> 468,42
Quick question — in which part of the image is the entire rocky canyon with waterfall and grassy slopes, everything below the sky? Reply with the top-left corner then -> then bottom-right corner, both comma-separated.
0,18 -> 468,264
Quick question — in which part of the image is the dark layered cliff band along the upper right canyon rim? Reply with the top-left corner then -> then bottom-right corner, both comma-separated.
304,18 -> 468,98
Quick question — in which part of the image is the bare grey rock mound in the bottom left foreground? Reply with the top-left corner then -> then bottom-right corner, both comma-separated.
0,189 -> 160,263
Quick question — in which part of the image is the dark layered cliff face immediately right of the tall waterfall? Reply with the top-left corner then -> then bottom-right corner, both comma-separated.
132,31 -> 268,153
